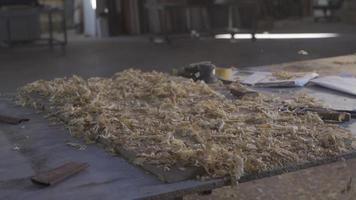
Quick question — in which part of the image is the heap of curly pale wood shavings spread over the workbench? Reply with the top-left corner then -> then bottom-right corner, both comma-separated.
18,70 -> 354,180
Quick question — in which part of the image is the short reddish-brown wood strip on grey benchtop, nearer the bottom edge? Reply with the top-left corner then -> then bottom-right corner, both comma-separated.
31,162 -> 89,186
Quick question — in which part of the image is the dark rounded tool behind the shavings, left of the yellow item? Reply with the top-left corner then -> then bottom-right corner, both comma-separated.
177,62 -> 218,83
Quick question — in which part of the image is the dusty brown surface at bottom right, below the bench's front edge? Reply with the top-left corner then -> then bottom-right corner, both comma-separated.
184,159 -> 356,200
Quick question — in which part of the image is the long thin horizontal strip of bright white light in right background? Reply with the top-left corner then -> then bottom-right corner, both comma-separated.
215,33 -> 339,40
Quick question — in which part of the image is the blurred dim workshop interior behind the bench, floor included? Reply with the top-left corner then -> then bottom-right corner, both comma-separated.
0,0 -> 356,91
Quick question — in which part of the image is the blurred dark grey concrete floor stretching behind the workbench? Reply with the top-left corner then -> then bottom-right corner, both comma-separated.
0,21 -> 356,92
